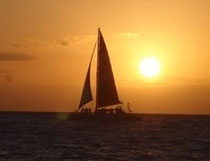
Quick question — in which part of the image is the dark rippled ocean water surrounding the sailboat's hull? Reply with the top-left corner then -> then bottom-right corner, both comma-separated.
0,112 -> 210,161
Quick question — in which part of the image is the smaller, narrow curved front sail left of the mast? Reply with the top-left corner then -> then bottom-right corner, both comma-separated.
78,44 -> 96,109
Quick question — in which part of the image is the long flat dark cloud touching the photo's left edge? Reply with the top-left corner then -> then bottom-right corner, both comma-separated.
0,52 -> 35,61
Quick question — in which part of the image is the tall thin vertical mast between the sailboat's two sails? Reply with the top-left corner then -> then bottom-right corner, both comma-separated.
95,28 -> 100,111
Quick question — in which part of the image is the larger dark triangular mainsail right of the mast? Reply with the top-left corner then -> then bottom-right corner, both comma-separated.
96,29 -> 121,110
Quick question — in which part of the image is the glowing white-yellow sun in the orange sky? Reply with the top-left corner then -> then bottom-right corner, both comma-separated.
139,56 -> 160,78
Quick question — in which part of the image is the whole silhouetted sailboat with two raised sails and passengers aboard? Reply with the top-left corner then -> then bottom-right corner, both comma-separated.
71,28 -> 139,120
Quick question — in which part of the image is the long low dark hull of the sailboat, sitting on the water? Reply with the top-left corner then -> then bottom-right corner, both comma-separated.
69,112 -> 142,122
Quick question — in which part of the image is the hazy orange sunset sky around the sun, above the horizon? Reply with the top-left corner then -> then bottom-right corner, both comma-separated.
0,0 -> 210,114
